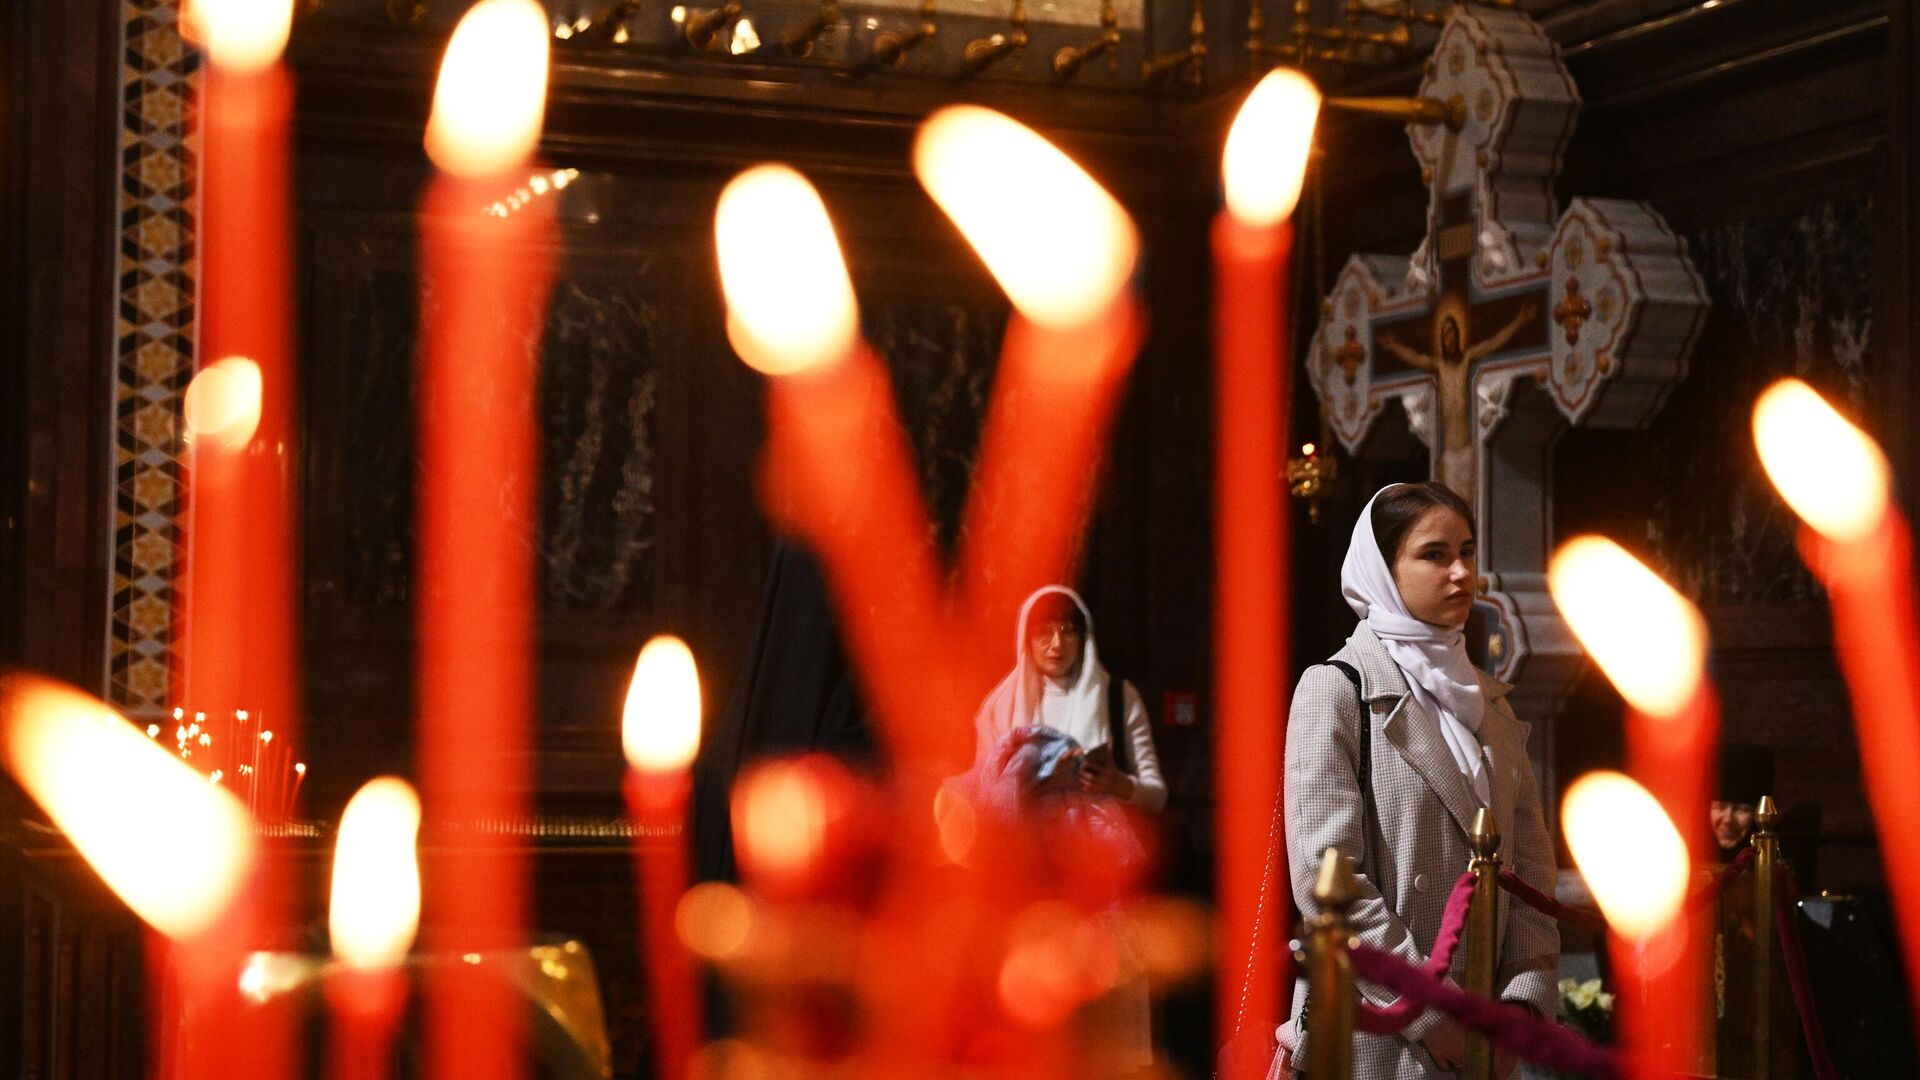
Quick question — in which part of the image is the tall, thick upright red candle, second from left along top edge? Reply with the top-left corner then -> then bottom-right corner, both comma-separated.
415,0 -> 553,1080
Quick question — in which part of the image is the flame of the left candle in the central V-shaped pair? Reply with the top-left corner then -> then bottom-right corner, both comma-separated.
714,165 -> 858,375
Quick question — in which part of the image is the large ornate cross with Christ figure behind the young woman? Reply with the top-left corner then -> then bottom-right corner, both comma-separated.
1308,6 -> 1707,726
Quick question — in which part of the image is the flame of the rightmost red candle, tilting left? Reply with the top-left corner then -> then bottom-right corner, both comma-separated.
1753,379 -> 1887,542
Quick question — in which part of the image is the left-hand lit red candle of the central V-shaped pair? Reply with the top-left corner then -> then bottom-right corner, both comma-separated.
714,165 -> 968,764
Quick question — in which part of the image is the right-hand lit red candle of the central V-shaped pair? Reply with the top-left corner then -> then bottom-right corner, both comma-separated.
914,106 -> 1140,653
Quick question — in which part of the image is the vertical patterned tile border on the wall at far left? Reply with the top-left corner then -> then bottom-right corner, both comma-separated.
106,0 -> 200,715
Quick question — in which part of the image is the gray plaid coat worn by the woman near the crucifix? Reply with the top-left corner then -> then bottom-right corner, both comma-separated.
1281,623 -> 1559,1080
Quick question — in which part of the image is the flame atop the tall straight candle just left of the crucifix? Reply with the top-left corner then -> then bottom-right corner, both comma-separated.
1221,67 -> 1321,229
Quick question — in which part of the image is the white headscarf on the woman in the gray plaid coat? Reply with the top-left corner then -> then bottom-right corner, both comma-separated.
1340,484 -> 1492,805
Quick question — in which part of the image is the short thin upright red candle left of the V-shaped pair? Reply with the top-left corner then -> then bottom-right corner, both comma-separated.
620,636 -> 701,1080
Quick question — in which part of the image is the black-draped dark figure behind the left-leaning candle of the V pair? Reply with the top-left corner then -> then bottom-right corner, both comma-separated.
689,540 -> 874,882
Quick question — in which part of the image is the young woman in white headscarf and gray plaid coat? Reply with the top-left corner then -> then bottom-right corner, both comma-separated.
1279,482 -> 1559,1080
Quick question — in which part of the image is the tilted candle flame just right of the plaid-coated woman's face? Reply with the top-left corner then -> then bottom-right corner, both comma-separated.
1548,536 -> 1707,717
